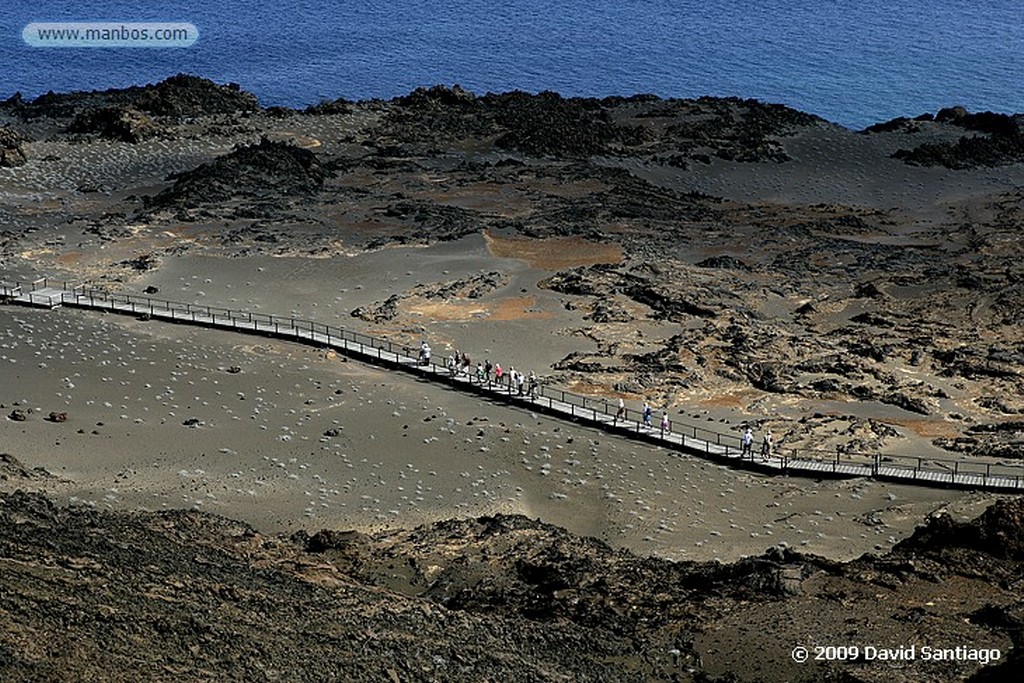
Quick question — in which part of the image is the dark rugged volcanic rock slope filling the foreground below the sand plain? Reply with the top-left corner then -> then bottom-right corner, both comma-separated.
0,491 -> 1024,683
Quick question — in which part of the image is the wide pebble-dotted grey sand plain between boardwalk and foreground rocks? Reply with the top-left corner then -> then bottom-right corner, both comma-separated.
0,301 -> 992,560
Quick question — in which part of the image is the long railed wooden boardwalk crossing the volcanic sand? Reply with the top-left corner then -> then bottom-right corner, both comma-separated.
0,281 -> 1024,493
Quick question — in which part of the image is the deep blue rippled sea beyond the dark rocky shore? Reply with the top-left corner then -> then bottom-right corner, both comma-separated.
0,0 -> 1024,128
